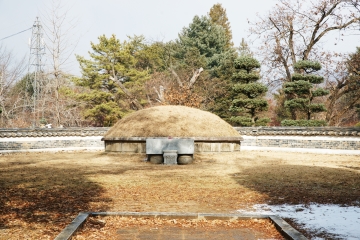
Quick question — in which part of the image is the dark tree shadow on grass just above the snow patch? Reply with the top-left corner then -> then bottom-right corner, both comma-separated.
232,165 -> 360,206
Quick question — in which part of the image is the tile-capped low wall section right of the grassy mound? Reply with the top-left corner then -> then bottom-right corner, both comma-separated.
235,127 -> 360,155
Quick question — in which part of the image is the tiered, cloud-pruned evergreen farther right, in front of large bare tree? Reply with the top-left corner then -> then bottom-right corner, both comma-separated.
281,60 -> 329,126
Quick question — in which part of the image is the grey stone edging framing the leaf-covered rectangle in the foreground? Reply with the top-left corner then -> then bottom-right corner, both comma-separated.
55,212 -> 307,240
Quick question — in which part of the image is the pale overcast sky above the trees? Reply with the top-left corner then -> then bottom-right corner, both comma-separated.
0,0 -> 360,74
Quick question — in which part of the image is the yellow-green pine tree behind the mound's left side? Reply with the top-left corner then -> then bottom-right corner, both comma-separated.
74,35 -> 148,126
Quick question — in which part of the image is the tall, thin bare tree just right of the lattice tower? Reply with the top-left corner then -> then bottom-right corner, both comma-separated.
42,0 -> 81,126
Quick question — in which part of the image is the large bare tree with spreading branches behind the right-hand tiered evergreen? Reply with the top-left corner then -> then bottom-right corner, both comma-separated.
250,0 -> 360,86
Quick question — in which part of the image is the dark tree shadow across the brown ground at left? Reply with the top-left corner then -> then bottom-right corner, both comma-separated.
0,159 -> 110,229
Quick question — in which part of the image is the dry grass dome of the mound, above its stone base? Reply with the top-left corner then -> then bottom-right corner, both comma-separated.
104,106 -> 240,139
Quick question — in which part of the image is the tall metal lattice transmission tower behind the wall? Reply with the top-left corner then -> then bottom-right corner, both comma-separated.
26,17 -> 45,127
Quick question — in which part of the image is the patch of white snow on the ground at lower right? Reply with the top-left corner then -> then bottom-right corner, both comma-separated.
238,203 -> 360,240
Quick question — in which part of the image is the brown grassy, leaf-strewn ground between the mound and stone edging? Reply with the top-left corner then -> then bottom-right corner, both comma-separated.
0,151 -> 360,239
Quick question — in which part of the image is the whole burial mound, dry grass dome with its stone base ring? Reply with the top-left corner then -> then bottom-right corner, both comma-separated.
103,106 -> 242,153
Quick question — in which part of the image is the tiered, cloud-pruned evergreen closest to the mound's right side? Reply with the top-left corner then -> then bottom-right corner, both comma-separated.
230,56 -> 270,126
